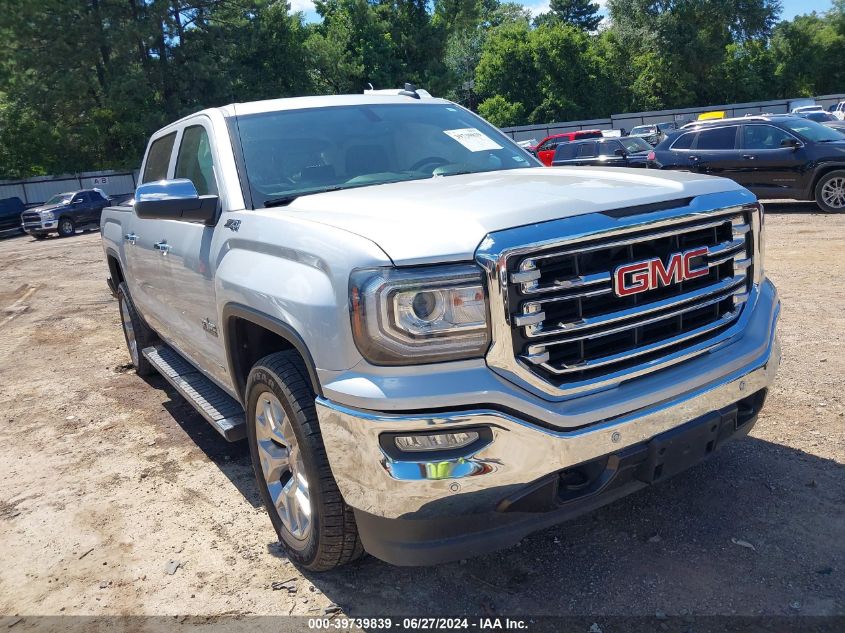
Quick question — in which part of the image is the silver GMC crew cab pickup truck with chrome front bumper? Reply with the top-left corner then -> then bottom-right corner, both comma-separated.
101,90 -> 780,570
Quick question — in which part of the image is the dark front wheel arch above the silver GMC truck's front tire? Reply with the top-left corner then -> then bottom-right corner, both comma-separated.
221,303 -> 323,403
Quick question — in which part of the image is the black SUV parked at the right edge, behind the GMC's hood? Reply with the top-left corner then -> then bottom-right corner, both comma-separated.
648,115 -> 845,212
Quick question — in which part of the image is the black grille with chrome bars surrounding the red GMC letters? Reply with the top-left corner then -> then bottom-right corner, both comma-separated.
508,208 -> 753,388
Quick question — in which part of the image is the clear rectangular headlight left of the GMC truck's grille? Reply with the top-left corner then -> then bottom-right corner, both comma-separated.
349,265 -> 490,365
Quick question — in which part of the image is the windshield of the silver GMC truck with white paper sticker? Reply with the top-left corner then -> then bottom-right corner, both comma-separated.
238,103 -> 539,207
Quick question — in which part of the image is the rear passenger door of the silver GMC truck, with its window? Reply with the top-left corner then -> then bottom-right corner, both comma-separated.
123,131 -> 176,337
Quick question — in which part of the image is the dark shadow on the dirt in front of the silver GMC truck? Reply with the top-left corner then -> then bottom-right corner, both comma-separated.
298,438 -> 845,616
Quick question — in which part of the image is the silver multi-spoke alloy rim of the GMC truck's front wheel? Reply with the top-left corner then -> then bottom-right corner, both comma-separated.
253,391 -> 311,541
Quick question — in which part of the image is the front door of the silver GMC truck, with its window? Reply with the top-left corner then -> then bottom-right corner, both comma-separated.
157,117 -> 227,384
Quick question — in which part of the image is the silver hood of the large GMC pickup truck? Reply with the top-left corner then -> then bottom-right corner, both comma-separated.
285,167 -> 742,265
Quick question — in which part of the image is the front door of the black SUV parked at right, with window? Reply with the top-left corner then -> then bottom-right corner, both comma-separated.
737,123 -> 807,198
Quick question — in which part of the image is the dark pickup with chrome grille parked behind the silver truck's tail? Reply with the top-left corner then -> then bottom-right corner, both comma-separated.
21,189 -> 111,239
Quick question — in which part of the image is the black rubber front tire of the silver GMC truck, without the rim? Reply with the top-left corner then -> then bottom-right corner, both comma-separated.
246,351 -> 364,572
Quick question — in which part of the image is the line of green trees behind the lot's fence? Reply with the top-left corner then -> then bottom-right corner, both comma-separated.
0,0 -> 845,178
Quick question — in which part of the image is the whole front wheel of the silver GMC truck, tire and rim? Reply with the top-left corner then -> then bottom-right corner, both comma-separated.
246,351 -> 363,571
